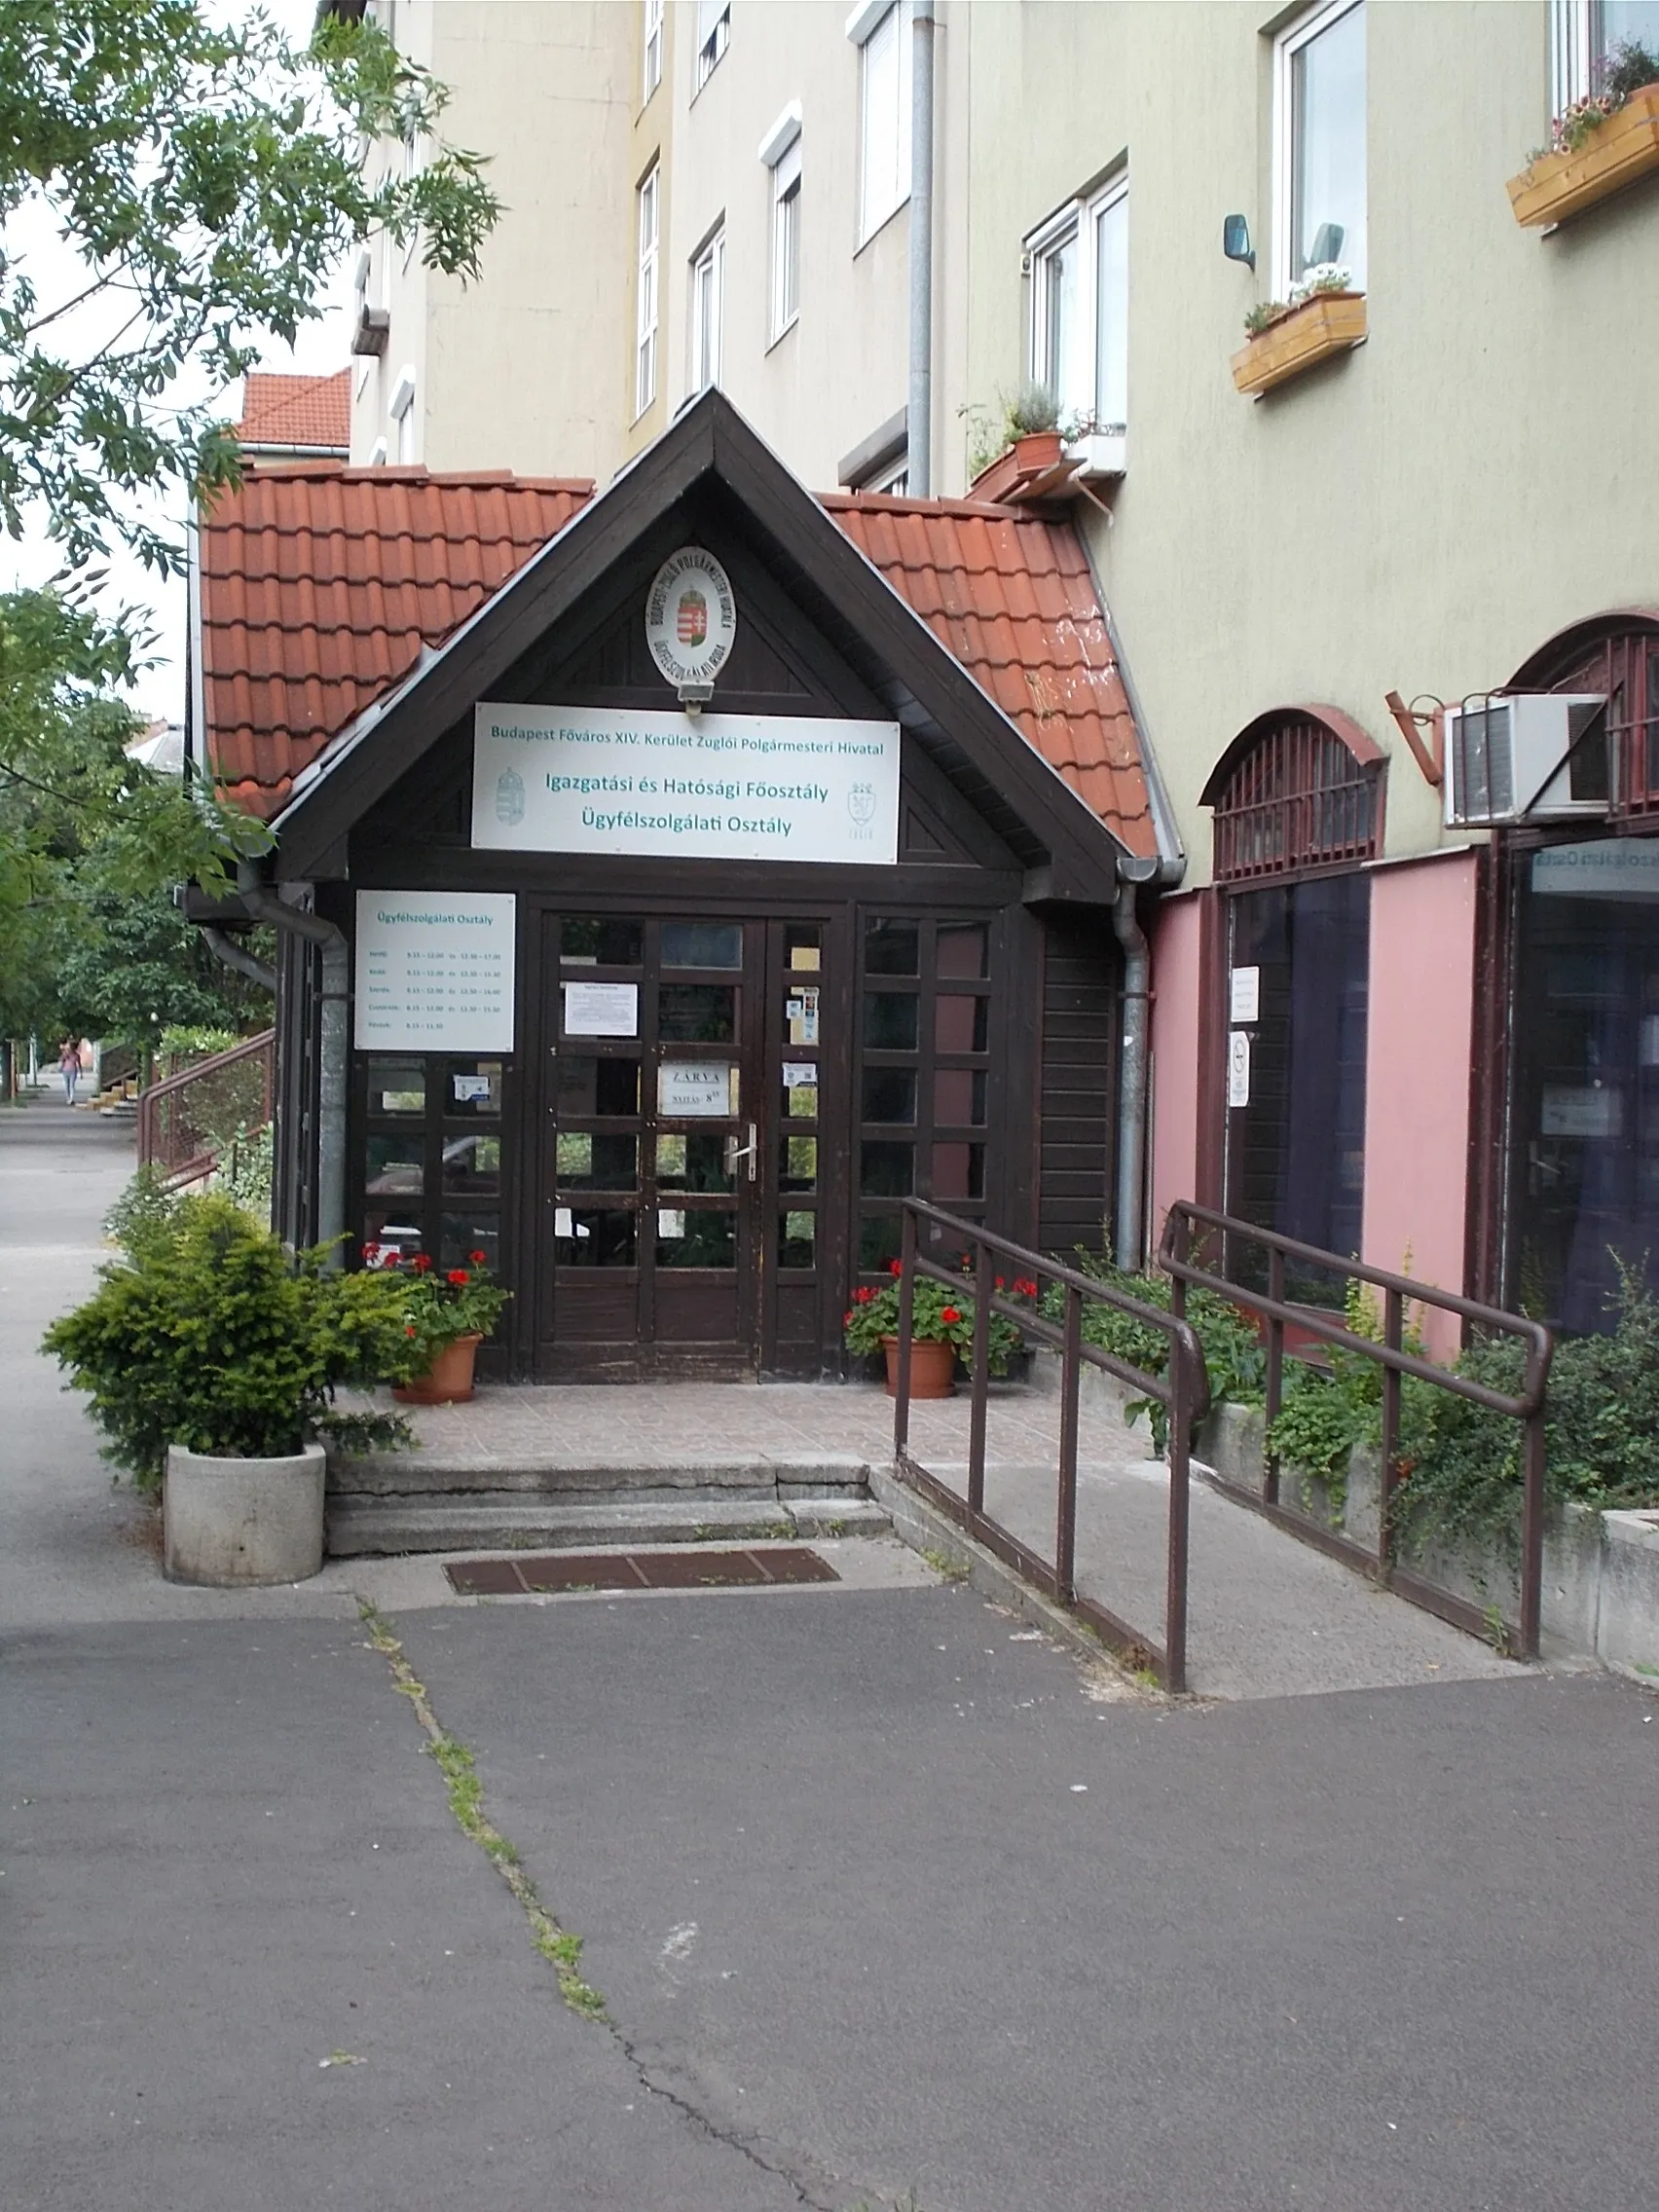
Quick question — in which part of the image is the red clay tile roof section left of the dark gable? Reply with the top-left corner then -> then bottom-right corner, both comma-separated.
199,461 -> 593,819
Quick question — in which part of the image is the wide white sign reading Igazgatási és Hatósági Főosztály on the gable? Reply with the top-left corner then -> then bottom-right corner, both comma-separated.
473,706 -> 898,863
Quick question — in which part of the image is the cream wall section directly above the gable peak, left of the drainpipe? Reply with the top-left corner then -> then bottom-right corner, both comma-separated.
664,0 -> 909,489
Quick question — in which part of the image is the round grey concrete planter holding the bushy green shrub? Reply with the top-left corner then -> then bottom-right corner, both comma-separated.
162,1445 -> 325,1591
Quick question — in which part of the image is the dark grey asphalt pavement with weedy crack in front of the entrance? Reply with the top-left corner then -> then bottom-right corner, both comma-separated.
0,1104 -> 1659,2212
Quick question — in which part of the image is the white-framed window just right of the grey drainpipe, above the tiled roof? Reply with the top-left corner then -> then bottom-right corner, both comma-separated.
1026,172 -> 1128,438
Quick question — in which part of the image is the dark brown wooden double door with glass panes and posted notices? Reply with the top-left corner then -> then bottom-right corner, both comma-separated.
539,913 -> 823,1378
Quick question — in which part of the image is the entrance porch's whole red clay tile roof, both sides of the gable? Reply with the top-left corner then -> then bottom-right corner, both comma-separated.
202,462 -> 1157,856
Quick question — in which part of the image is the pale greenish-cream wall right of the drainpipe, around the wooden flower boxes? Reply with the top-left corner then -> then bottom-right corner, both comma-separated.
944,0 -> 1659,883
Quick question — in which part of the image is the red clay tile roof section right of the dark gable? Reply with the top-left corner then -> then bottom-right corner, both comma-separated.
823,491 -> 1157,859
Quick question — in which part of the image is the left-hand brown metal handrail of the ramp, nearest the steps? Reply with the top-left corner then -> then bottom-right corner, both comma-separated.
894,1198 -> 1210,1690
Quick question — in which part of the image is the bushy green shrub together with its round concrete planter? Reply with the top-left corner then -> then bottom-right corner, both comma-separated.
42,1193 -> 414,1588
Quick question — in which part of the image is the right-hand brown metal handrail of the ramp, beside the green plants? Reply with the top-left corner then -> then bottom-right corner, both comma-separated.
1160,1198 -> 1555,1659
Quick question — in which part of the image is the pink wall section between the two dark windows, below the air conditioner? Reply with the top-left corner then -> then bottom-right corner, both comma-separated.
1363,852 -> 1475,1358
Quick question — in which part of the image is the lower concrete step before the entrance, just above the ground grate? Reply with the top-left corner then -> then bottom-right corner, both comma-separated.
327,1489 -> 892,1560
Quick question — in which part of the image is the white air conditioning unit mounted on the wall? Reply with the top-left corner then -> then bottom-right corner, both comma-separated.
1440,692 -> 1610,830
